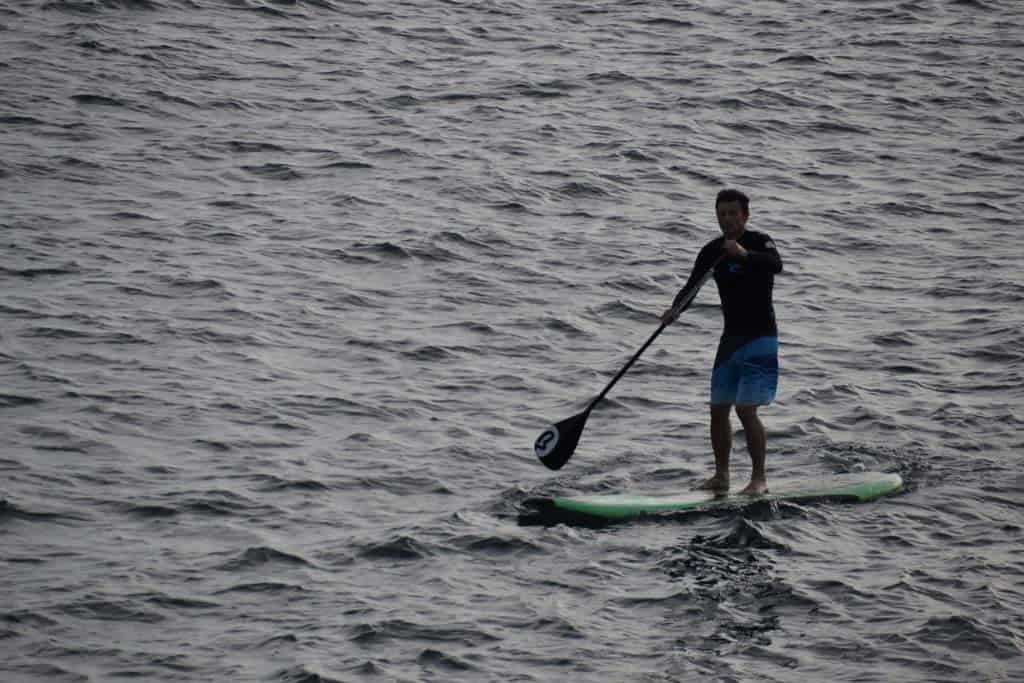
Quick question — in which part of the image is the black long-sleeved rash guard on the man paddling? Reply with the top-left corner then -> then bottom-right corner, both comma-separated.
675,230 -> 782,366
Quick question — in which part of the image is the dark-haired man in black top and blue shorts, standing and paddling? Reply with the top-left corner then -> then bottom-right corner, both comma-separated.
662,189 -> 782,496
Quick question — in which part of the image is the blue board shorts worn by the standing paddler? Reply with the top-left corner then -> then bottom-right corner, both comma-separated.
711,336 -> 778,405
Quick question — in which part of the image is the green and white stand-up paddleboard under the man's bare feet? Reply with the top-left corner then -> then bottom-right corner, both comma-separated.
520,472 -> 903,523
